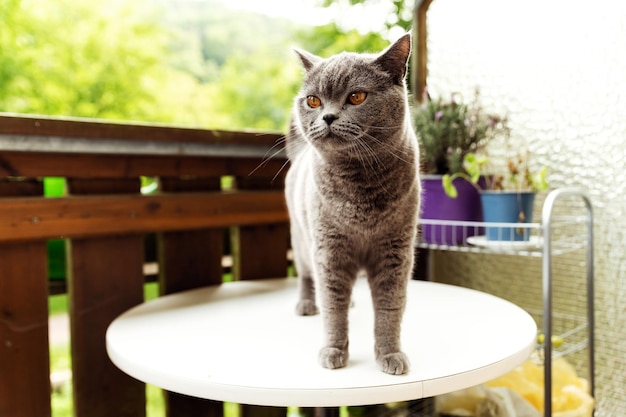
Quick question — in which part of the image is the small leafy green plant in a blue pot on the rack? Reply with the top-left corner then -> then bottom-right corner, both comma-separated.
442,151 -> 548,241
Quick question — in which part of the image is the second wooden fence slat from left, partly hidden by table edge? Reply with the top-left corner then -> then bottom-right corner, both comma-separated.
68,178 -> 146,417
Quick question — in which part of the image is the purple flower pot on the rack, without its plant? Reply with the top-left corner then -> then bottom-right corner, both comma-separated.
421,175 -> 483,245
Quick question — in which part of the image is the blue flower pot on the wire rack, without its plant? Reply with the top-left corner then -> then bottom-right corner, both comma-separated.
480,191 -> 535,241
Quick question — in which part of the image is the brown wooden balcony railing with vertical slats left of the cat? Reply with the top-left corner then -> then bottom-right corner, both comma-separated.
0,115 -> 288,417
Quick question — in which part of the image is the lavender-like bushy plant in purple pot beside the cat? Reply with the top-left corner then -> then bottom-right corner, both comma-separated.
414,90 -> 508,245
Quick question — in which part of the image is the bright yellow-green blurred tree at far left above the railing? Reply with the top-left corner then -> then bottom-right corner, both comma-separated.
0,0 -> 171,120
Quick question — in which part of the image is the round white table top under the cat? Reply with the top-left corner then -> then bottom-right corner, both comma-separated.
106,278 -> 536,407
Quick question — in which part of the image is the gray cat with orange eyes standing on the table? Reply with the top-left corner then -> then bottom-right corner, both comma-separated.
285,34 -> 420,374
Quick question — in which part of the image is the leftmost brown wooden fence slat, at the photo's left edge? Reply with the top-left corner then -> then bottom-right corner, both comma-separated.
0,180 -> 51,417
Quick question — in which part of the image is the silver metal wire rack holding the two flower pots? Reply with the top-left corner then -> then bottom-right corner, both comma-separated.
409,189 -> 595,416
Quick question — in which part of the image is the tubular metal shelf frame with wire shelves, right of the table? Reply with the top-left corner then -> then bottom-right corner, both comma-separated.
417,188 -> 595,416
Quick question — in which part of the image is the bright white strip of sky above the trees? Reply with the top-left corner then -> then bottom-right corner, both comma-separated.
217,0 -> 390,32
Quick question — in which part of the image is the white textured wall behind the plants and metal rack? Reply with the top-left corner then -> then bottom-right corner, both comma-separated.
428,0 -> 626,417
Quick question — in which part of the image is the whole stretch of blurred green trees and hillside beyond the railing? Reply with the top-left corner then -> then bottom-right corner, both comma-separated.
0,0 -> 400,130
